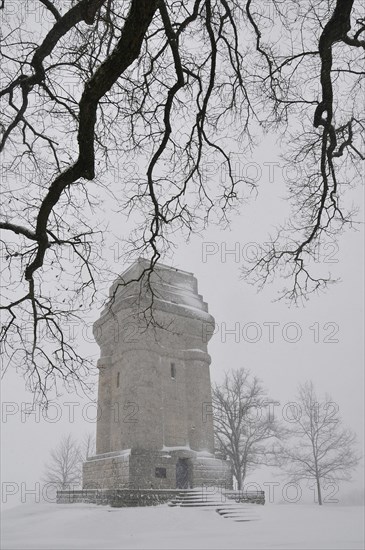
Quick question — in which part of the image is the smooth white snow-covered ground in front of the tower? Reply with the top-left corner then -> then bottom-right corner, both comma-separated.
1,504 -> 364,550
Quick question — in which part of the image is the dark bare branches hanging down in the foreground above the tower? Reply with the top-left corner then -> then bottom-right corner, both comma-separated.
0,0 -> 365,399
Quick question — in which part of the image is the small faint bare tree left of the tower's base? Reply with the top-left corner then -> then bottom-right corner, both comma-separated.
43,434 -> 95,490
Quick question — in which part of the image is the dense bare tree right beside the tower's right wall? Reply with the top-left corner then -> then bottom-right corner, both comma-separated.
212,368 -> 281,490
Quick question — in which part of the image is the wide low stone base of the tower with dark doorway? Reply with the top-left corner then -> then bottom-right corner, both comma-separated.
83,448 -> 232,490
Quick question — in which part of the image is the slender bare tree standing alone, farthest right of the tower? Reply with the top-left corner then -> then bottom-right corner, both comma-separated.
277,382 -> 360,505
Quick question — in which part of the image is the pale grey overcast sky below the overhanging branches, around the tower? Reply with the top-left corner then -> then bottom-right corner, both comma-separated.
1,132 -> 364,504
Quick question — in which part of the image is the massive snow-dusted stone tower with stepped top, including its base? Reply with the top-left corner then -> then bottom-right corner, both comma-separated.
83,259 -> 231,489
